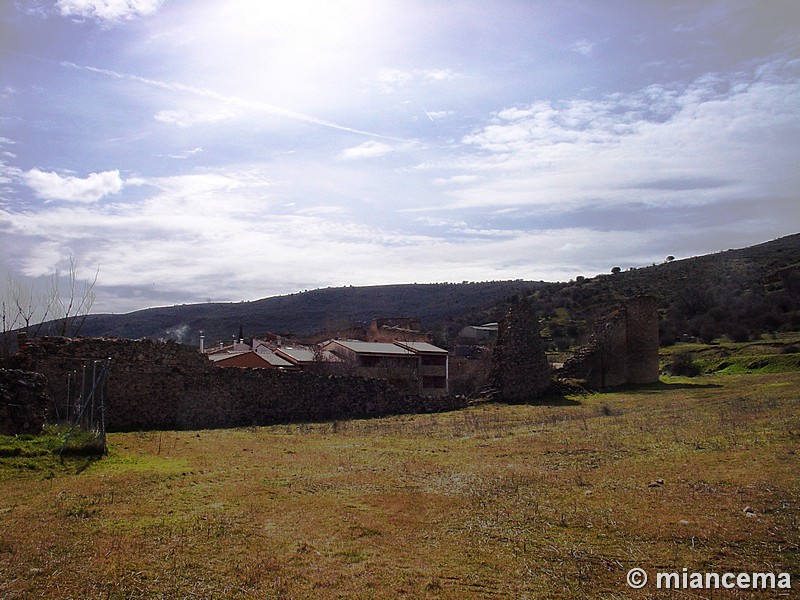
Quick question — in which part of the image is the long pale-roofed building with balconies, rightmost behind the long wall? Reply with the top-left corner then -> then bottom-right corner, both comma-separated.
323,340 -> 449,396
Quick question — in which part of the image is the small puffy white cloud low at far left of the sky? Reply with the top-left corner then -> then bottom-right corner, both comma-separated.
22,169 -> 123,202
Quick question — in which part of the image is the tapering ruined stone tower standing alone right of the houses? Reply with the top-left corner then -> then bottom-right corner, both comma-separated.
491,301 -> 550,402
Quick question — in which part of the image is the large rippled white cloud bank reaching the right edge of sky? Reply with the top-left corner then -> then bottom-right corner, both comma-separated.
448,56 -> 800,210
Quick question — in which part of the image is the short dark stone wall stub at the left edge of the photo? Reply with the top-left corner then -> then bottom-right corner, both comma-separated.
0,369 -> 52,435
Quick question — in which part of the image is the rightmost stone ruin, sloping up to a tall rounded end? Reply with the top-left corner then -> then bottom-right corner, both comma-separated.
558,296 -> 659,388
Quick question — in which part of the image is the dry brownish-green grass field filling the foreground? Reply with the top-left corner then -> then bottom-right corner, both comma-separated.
0,372 -> 800,599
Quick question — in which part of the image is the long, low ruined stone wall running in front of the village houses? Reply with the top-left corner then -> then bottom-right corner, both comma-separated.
20,338 -> 465,431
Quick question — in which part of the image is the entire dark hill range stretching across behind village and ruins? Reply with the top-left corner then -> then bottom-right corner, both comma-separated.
42,234 -> 800,348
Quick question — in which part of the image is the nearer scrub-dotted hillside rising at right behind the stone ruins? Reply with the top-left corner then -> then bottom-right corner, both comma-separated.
448,234 -> 800,348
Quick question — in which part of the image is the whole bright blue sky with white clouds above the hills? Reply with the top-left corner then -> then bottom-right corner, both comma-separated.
0,0 -> 800,313
